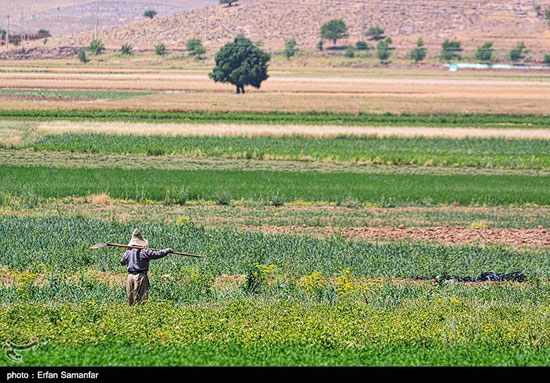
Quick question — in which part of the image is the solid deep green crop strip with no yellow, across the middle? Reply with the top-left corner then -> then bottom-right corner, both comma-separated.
0,166 -> 550,206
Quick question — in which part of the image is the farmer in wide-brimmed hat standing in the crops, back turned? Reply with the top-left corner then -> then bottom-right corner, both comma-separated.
120,229 -> 174,306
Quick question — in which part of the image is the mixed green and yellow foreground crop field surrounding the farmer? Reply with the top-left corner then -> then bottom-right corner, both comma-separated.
0,218 -> 550,365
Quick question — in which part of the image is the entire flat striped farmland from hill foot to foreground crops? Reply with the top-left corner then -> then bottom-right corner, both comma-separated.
0,58 -> 550,367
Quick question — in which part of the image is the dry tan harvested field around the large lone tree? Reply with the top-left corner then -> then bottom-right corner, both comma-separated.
0,59 -> 550,114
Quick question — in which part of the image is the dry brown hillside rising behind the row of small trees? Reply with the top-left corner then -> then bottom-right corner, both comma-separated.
48,0 -> 550,50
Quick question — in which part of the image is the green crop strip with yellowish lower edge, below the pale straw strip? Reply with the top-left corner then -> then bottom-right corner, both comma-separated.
16,131 -> 550,169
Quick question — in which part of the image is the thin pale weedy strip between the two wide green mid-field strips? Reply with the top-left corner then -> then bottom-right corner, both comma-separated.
0,149 -> 550,176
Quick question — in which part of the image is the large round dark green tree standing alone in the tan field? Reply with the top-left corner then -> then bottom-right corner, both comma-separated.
209,35 -> 271,93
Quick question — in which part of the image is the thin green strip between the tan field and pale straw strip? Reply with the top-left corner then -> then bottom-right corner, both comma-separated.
0,109 -> 550,129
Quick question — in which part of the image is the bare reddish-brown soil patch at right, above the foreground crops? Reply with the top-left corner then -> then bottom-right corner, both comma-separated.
258,226 -> 550,247
